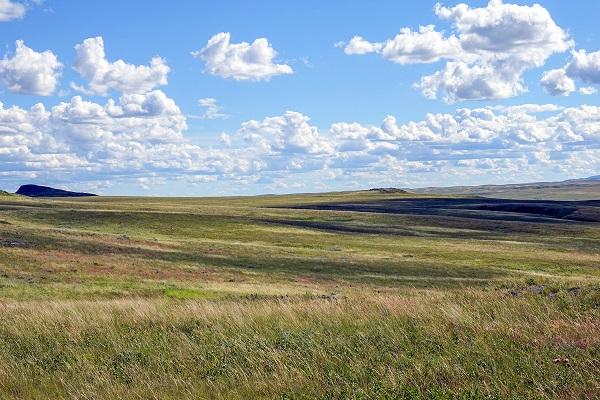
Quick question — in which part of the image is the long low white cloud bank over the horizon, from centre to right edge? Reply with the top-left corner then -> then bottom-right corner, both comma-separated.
234,104 -> 600,188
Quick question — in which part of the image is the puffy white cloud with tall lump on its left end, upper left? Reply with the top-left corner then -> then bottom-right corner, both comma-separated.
71,36 -> 170,95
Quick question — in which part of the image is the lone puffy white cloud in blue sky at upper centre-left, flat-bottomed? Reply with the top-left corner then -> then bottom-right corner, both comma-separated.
192,32 -> 294,81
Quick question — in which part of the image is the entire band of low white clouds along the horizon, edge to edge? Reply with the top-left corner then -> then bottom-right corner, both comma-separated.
0,95 -> 600,191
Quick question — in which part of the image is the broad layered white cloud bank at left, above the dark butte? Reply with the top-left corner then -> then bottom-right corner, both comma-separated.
0,91 -> 252,188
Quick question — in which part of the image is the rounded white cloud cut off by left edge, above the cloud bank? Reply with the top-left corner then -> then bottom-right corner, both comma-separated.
0,40 -> 62,96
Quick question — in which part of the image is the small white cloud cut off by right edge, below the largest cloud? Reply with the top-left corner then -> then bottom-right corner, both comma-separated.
540,50 -> 600,96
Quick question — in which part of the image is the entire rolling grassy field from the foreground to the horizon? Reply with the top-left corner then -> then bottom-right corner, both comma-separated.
0,191 -> 600,399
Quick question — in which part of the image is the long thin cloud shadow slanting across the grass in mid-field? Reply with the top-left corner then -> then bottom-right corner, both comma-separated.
0,227 -> 507,287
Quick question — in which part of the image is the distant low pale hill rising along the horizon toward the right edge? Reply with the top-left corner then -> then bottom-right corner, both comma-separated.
411,175 -> 600,200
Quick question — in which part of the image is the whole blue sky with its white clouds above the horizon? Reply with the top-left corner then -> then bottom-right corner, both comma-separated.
0,0 -> 600,196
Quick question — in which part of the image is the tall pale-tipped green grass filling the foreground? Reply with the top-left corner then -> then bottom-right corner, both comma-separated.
0,289 -> 600,399
